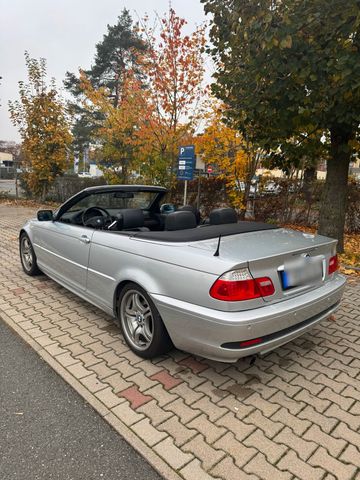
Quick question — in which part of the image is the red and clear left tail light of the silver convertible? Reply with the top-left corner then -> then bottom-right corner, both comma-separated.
210,268 -> 275,302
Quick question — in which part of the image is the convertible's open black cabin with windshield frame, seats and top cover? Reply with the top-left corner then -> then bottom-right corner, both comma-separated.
54,185 -> 277,242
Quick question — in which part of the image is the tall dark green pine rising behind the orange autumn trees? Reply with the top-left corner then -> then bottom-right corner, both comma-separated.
64,9 -> 146,151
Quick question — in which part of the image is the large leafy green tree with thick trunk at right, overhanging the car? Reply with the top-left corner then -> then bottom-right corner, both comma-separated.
202,0 -> 360,251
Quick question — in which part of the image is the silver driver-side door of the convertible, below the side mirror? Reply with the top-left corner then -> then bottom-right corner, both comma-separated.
34,221 -> 94,292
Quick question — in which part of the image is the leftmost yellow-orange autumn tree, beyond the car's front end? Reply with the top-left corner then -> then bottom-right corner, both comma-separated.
9,52 -> 72,199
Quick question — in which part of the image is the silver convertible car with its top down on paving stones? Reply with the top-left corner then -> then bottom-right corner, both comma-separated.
20,185 -> 345,362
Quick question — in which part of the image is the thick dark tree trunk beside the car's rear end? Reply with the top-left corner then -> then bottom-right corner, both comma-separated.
319,128 -> 352,253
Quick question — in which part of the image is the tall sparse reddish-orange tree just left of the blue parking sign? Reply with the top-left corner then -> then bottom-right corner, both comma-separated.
142,8 -> 206,183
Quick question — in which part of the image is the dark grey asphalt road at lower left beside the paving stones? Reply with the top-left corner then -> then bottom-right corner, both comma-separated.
0,319 -> 161,480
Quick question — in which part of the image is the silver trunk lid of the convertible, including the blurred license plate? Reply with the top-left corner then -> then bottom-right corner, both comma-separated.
191,228 -> 336,303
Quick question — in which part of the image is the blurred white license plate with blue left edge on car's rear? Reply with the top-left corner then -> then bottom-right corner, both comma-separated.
280,256 -> 323,290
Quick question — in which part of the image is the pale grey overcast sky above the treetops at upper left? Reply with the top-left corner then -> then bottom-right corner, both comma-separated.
0,0 -> 205,140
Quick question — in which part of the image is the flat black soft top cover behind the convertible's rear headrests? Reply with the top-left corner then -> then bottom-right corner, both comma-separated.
133,222 -> 278,242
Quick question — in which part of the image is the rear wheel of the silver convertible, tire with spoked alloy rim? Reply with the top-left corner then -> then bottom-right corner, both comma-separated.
118,283 -> 173,358
